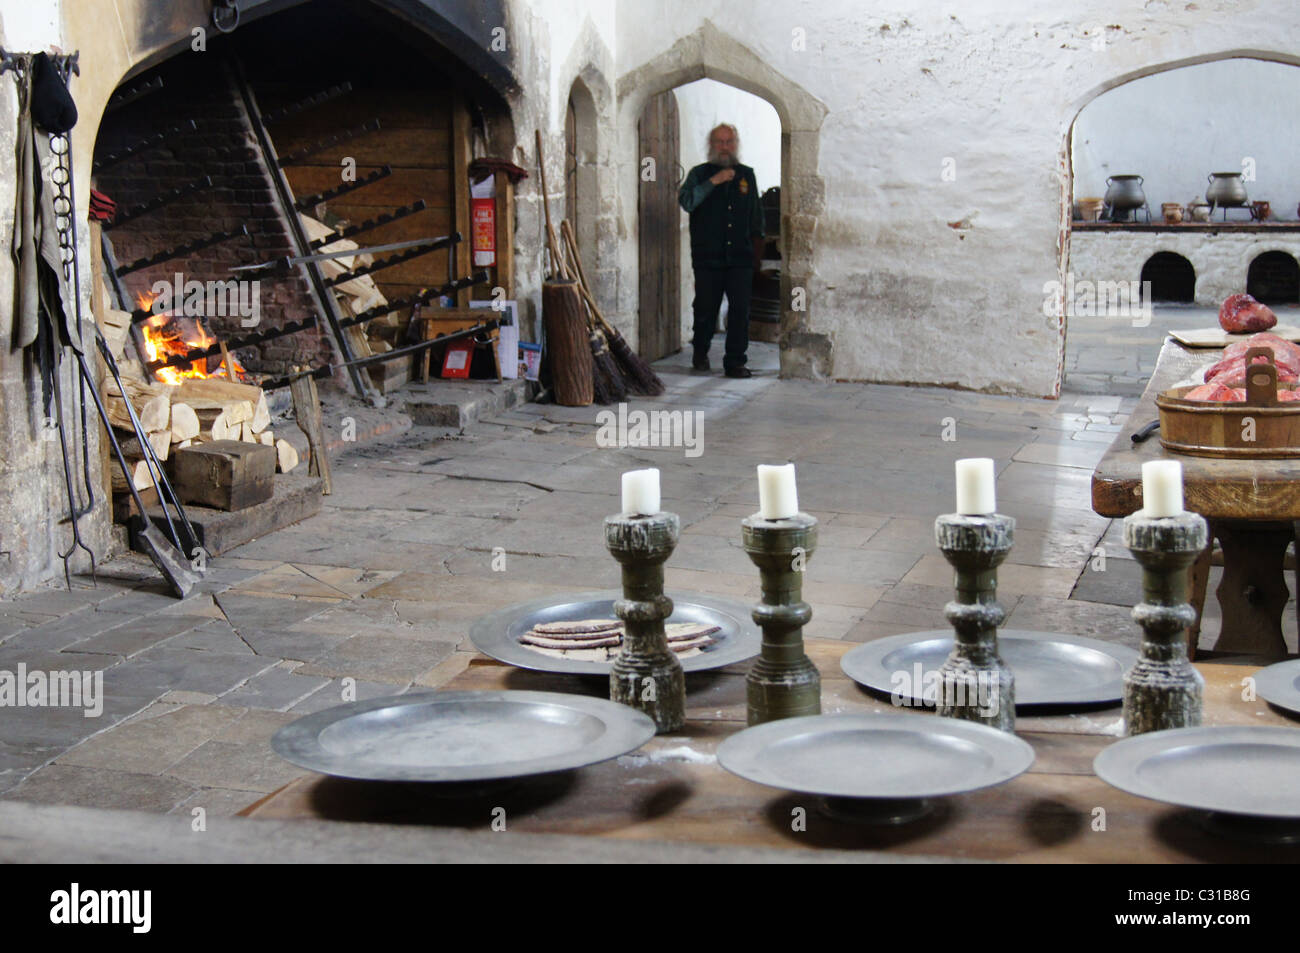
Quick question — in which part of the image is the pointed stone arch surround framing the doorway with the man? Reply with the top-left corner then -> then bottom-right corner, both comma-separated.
618,20 -> 833,377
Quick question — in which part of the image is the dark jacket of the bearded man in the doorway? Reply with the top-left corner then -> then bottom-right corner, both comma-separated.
677,163 -> 763,268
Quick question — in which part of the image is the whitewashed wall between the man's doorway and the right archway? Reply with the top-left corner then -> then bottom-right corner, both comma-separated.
616,0 -> 1300,395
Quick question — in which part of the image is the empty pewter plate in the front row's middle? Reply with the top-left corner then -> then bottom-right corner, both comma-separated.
718,711 -> 1034,800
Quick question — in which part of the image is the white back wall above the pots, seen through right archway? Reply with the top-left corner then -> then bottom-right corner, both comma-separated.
1073,60 -> 1300,221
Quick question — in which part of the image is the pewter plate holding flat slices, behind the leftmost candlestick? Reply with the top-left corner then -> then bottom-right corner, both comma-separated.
469,590 -> 763,675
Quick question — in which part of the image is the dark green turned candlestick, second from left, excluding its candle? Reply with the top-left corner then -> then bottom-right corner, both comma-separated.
741,512 -> 822,724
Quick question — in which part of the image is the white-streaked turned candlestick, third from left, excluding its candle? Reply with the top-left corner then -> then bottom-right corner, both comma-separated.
935,514 -> 1015,731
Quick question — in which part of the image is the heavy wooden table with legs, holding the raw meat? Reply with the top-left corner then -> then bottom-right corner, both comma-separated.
1092,338 -> 1300,658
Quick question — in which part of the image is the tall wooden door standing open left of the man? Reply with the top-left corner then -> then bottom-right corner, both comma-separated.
637,90 -> 683,360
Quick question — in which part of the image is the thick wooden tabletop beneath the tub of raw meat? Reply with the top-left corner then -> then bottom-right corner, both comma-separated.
1092,341 -> 1300,520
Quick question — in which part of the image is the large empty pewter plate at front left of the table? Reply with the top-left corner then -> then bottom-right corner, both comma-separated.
270,692 -> 655,781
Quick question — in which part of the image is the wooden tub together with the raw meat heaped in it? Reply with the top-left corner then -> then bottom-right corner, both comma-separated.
1156,334 -> 1300,458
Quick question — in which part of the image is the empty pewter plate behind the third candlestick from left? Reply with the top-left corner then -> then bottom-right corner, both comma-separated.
840,629 -> 1138,709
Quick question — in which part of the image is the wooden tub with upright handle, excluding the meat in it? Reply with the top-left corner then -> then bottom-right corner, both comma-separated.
1156,347 -> 1300,459
